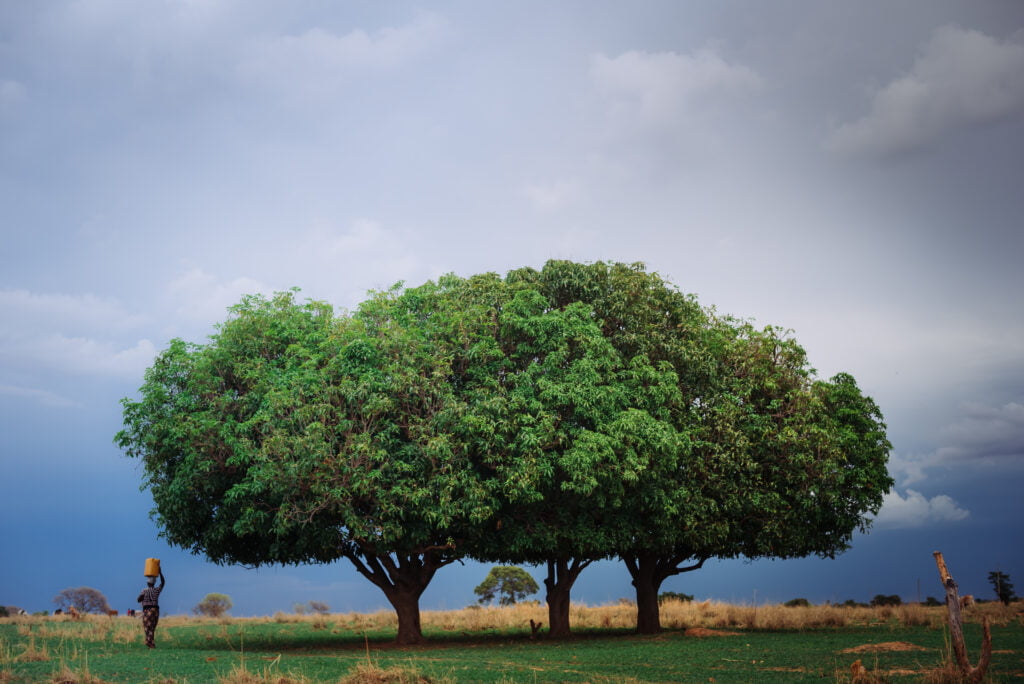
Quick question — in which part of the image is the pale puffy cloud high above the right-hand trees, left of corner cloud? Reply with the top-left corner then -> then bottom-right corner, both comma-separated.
590,49 -> 762,125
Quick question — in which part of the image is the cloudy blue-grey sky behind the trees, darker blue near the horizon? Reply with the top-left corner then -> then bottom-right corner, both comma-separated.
0,0 -> 1024,615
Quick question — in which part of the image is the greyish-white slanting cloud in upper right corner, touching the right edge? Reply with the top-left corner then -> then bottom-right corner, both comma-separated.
828,27 -> 1024,154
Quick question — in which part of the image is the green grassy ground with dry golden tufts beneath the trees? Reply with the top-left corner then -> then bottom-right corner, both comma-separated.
0,602 -> 1024,684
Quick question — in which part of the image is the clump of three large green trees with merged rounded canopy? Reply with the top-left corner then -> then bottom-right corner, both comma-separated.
117,261 -> 892,643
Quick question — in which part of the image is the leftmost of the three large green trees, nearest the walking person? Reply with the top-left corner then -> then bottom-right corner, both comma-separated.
117,285 -> 499,643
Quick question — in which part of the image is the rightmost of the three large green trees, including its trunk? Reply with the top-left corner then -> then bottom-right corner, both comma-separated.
621,318 -> 892,633
